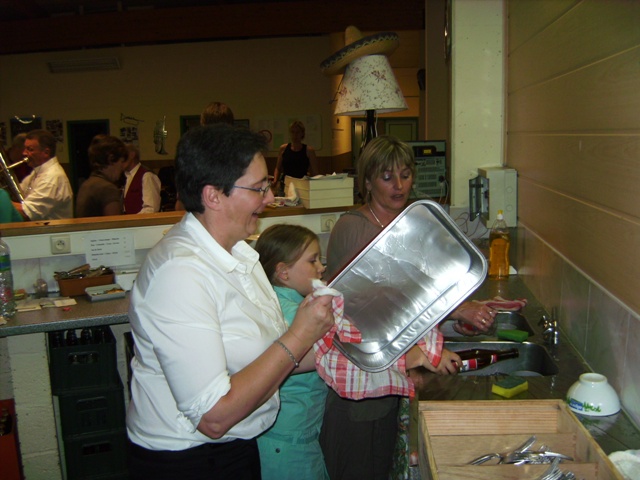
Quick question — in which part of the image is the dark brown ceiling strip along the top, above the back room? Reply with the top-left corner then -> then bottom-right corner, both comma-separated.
0,0 -> 424,54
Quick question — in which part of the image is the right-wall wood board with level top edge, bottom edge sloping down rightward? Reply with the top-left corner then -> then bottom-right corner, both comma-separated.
507,134 -> 640,217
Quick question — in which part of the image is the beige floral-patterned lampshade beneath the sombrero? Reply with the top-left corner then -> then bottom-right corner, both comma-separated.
334,55 -> 408,116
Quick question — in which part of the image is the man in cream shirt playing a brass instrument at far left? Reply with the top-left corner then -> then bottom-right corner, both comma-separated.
13,130 -> 73,220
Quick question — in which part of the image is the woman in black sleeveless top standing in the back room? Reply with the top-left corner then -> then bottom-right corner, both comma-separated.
273,120 -> 318,195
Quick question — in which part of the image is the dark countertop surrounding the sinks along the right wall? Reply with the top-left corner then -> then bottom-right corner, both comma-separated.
411,275 -> 640,454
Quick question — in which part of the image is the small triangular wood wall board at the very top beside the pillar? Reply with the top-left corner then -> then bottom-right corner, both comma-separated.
509,0 -> 582,51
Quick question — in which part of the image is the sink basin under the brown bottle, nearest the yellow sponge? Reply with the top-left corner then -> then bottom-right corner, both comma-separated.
444,341 -> 558,377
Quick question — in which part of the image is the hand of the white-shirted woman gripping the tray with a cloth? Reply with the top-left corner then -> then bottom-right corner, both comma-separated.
289,294 -> 335,346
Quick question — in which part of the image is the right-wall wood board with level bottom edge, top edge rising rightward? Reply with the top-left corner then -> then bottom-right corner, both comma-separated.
508,45 -> 640,133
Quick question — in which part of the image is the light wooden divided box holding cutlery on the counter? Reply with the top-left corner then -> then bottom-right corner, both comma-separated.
420,400 -> 623,480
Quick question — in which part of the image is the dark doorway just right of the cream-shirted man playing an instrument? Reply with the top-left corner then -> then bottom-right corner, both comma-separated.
67,120 -> 109,196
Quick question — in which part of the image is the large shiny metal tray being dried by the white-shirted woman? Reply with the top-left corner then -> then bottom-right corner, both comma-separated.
329,200 -> 487,372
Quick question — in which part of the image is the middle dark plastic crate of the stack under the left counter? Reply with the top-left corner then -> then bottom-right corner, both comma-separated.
54,384 -> 125,437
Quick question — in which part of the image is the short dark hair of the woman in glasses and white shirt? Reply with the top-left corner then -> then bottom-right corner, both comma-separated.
175,123 -> 267,213
